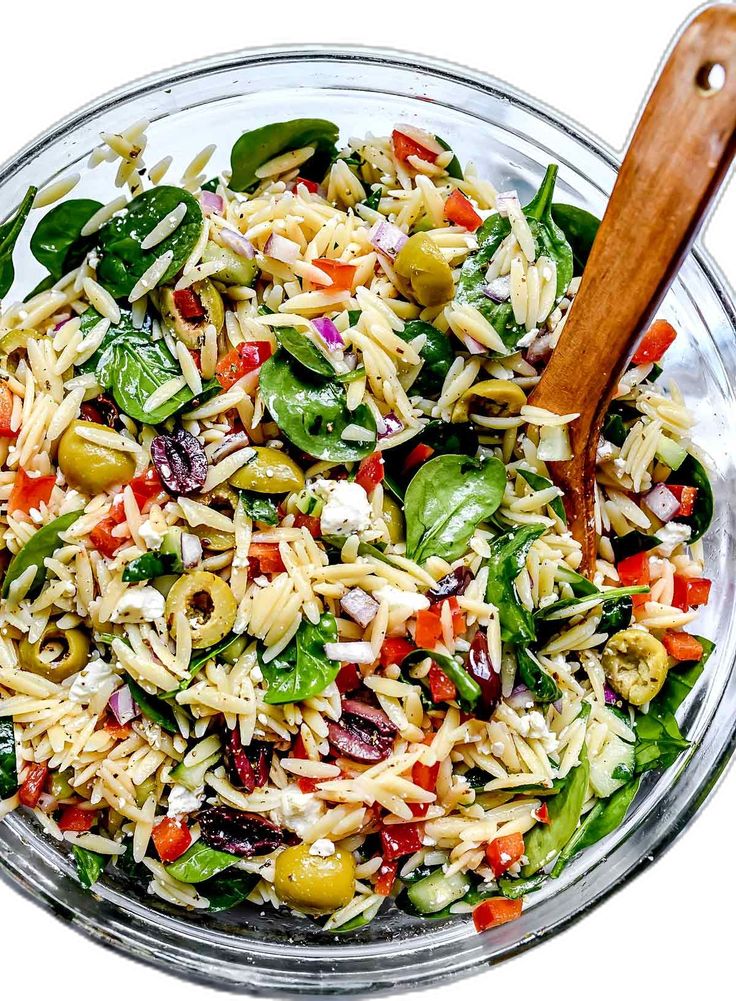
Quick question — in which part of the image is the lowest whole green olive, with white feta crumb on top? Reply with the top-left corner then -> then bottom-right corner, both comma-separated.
273,845 -> 355,914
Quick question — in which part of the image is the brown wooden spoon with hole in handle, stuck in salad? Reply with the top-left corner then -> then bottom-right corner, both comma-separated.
530,4 -> 736,576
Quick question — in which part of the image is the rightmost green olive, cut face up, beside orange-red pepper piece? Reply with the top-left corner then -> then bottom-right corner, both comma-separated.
602,629 -> 670,706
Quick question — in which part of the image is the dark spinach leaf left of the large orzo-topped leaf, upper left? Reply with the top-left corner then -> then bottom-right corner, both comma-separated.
31,198 -> 102,291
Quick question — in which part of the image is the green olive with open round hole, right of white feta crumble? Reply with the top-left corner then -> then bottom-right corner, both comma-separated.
166,570 -> 237,650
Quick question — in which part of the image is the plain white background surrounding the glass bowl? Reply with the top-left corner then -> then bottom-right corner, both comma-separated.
0,0 -> 736,1001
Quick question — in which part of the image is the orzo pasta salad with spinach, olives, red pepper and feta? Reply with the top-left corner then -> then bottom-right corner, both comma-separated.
0,119 -> 713,932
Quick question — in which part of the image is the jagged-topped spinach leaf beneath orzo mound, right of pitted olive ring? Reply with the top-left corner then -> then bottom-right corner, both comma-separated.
260,612 -> 339,706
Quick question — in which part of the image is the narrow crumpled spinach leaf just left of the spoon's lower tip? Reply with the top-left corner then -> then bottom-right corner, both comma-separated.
486,525 -> 546,643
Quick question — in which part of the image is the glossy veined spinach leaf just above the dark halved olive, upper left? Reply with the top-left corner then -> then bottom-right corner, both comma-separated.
80,307 -> 221,424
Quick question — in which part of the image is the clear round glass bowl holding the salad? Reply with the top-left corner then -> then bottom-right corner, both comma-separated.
0,47 -> 736,995
